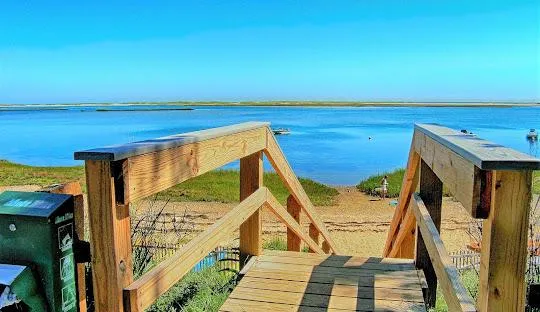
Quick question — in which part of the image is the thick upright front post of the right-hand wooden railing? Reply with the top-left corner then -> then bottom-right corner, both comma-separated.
477,170 -> 532,311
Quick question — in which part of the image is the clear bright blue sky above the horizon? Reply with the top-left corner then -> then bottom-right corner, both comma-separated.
0,0 -> 540,103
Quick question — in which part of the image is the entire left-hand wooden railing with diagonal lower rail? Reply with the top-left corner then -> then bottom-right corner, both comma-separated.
75,122 -> 338,312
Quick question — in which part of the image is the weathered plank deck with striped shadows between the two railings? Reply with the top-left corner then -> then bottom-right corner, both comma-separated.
220,250 -> 426,312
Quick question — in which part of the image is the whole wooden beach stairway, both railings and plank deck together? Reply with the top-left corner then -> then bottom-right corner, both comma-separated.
75,122 -> 540,312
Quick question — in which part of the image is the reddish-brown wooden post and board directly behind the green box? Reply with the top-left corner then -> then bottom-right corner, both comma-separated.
41,181 -> 87,312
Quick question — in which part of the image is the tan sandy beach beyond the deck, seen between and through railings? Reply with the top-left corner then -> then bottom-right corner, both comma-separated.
132,187 -> 471,256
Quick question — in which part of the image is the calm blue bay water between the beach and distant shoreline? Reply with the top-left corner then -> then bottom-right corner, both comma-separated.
0,106 -> 540,185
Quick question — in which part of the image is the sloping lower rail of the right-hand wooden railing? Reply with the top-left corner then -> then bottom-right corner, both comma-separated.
411,194 -> 476,311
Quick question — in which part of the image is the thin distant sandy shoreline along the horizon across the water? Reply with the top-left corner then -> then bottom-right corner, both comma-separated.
0,101 -> 540,110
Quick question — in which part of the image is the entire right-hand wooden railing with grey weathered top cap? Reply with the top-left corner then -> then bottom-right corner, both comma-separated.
383,124 -> 540,311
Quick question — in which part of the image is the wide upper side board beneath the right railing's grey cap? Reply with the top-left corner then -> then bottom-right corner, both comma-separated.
414,131 -> 490,218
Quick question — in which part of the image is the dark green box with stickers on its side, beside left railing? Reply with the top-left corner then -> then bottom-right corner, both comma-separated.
0,191 -> 78,312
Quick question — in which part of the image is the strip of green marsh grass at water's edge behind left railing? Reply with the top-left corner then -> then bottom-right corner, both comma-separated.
0,160 -> 338,206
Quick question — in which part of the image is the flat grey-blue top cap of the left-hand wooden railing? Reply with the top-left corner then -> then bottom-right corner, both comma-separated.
74,122 -> 270,161
